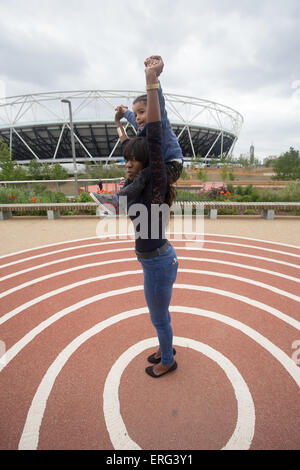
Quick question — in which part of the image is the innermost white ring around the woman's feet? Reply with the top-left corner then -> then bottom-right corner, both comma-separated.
103,336 -> 255,450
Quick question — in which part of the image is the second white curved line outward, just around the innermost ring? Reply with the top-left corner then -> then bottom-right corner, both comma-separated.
19,304 -> 300,450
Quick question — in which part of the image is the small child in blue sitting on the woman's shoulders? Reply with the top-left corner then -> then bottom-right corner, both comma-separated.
91,56 -> 183,211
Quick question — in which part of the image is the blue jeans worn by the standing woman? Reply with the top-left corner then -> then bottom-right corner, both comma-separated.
138,245 -> 178,366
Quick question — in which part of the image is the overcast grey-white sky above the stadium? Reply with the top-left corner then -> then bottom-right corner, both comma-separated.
0,0 -> 300,158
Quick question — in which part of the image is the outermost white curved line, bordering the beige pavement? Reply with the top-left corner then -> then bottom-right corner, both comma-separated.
0,232 -> 300,259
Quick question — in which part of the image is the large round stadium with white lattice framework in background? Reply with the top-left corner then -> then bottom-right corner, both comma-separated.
0,90 -> 243,163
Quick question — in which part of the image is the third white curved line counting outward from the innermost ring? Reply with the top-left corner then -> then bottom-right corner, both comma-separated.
0,280 -> 300,372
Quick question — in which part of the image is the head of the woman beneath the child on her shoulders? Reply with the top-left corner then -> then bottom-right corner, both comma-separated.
124,137 -> 149,180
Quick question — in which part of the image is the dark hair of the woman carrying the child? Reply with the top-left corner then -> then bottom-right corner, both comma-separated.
124,136 -> 176,207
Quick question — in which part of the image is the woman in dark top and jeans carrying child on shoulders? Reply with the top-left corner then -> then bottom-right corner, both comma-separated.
118,60 -> 178,378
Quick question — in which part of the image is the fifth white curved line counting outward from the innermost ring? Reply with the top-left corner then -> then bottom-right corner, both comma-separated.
0,256 -> 300,302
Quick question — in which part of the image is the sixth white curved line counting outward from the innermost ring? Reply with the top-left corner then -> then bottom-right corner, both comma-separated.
0,245 -> 300,282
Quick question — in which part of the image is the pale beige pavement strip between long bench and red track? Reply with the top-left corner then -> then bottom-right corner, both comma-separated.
0,216 -> 300,256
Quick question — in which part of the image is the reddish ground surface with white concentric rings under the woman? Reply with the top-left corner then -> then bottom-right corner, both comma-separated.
0,234 -> 300,450
